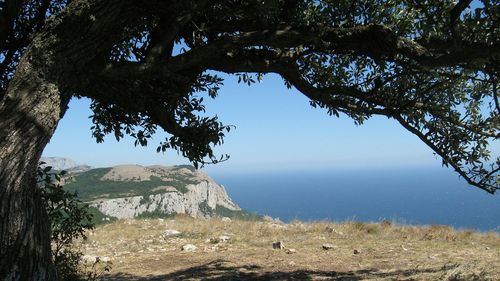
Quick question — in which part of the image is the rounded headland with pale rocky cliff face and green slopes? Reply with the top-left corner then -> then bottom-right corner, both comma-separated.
65,165 -> 242,219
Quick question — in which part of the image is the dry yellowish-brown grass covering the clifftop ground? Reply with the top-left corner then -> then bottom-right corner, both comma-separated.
80,216 -> 500,281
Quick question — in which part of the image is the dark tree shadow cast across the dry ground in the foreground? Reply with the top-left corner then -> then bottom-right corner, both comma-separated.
106,260 -> 450,281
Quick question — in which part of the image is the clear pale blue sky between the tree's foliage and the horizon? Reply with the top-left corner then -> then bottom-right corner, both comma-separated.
44,72 -> 468,172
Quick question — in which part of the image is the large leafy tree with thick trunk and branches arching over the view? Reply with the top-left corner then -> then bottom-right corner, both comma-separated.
0,0 -> 500,280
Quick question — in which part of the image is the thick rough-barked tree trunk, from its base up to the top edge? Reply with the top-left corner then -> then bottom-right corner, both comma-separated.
0,0 -> 143,280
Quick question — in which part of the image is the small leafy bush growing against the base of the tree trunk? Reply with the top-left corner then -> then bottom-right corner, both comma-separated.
37,162 -> 110,281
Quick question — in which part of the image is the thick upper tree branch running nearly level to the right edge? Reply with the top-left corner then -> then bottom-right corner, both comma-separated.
180,24 -> 500,67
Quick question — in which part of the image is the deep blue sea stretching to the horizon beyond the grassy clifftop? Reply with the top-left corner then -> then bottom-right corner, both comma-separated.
213,168 -> 500,232
